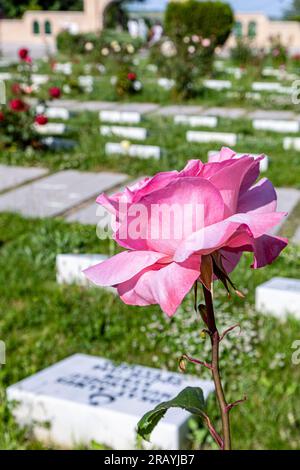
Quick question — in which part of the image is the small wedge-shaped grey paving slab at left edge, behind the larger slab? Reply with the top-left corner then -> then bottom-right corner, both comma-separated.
0,165 -> 48,193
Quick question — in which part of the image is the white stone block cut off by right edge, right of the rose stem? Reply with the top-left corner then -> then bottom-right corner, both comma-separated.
255,277 -> 300,319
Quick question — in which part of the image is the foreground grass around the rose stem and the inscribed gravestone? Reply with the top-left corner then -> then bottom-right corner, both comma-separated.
0,214 -> 300,449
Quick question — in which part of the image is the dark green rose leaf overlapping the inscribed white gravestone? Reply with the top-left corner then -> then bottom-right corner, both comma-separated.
137,387 -> 205,441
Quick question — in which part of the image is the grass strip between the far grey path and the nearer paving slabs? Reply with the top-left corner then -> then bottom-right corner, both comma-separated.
0,112 -> 300,187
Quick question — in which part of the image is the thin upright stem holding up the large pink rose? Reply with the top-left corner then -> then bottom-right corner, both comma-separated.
203,285 -> 231,450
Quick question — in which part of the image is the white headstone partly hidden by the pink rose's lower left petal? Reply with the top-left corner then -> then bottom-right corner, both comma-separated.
56,254 -> 108,286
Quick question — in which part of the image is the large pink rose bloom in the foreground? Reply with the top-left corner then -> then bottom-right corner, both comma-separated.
85,148 -> 287,316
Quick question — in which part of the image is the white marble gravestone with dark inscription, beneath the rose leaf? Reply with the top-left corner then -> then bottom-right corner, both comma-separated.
7,354 -> 213,450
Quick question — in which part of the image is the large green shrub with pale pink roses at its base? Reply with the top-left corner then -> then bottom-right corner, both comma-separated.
155,0 -> 234,98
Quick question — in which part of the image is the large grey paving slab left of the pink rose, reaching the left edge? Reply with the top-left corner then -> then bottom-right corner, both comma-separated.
0,170 -> 127,217
